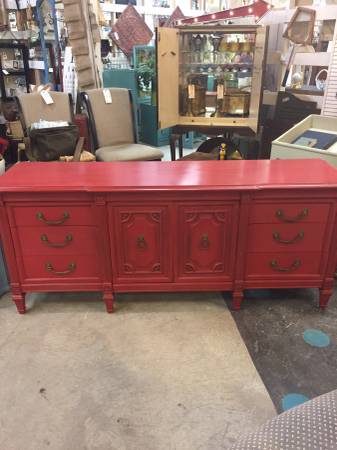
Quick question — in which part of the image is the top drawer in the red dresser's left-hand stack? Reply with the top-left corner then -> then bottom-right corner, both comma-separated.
12,205 -> 95,227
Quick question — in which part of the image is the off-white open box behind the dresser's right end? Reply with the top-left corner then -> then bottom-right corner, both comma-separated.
270,114 -> 337,167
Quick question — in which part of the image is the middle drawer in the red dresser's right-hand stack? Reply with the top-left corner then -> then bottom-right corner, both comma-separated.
248,222 -> 326,253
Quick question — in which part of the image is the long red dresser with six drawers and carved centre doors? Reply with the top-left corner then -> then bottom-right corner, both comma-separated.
0,160 -> 337,313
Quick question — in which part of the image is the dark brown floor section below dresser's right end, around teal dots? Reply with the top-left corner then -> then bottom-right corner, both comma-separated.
228,283 -> 337,412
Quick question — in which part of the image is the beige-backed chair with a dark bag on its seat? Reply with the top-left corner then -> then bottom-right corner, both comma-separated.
16,91 -> 84,161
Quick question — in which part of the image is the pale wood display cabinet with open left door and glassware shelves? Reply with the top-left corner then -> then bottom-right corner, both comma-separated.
157,25 -> 267,133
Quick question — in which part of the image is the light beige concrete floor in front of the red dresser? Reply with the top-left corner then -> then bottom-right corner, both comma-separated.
0,293 -> 275,450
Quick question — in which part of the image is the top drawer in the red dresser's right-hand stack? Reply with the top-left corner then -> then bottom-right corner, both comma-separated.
249,202 -> 329,223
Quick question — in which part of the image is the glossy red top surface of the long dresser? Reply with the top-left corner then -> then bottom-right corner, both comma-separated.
0,159 -> 337,192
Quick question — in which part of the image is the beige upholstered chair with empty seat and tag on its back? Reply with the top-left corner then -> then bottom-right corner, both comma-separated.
81,88 -> 163,161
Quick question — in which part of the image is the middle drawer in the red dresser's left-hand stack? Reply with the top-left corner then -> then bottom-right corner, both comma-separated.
17,226 -> 97,255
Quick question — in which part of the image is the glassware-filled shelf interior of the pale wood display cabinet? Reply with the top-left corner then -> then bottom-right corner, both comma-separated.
179,30 -> 256,117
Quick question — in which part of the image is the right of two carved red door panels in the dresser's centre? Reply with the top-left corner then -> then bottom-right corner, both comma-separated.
178,205 -> 237,280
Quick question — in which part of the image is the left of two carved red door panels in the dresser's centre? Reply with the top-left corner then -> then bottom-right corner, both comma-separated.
111,206 -> 171,282
